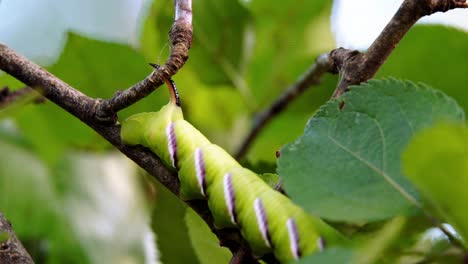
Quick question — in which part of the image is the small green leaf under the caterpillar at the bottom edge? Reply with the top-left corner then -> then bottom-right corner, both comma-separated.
185,209 -> 232,264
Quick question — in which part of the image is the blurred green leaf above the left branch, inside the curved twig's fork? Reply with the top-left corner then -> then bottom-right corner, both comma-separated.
49,33 -> 147,98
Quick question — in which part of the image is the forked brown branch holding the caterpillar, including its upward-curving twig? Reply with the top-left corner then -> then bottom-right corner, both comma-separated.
0,0 -> 266,259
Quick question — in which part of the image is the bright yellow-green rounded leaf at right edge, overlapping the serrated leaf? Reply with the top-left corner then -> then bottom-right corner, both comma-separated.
403,123 -> 468,245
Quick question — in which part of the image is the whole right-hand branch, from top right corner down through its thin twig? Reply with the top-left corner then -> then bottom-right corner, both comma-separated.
234,0 -> 468,159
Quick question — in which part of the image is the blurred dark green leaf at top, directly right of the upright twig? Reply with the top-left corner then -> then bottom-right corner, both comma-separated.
189,0 -> 251,86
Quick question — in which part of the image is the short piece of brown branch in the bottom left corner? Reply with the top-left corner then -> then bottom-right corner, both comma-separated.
0,212 -> 34,264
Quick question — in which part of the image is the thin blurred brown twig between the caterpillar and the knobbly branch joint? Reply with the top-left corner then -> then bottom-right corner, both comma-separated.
234,54 -> 332,159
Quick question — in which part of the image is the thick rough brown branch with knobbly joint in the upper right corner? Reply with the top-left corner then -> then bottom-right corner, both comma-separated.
330,0 -> 468,97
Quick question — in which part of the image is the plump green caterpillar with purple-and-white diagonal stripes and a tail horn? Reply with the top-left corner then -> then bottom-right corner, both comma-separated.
121,74 -> 341,262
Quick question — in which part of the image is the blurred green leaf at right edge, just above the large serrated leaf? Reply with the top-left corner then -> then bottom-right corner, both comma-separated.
377,25 -> 468,111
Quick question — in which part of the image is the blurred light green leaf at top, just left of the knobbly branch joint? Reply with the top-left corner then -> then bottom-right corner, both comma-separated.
245,0 -> 335,105
